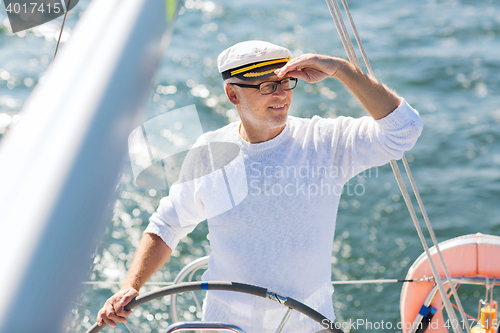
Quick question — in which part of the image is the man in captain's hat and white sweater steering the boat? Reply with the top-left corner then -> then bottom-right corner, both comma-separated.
97,41 -> 422,333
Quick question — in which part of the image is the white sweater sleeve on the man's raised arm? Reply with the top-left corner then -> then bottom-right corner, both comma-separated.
320,99 -> 423,184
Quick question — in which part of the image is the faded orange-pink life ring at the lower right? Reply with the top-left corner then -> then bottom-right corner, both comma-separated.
400,233 -> 500,333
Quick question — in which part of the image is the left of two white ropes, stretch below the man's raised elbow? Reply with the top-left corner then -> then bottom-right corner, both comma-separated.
391,160 -> 462,333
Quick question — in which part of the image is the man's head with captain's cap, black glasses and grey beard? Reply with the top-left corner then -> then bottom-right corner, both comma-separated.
217,41 -> 296,137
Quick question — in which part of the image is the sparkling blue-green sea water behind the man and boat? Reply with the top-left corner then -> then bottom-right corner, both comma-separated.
0,0 -> 500,332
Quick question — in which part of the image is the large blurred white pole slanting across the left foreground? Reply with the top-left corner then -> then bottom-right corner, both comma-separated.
0,0 -> 179,333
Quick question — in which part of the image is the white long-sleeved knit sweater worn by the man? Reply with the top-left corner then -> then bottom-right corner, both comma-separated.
145,100 -> 422,333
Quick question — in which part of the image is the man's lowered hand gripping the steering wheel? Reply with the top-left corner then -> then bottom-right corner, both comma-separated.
97,287 -> 139,327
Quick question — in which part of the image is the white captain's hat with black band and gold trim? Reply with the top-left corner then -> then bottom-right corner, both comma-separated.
217,40 -> 292,81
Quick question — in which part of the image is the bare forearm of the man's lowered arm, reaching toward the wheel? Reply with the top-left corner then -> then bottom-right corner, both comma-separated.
122,234 -> 172,290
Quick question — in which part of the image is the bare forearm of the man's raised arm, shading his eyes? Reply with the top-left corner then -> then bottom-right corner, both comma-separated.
333,59 -> 401,119
